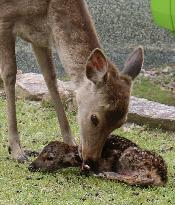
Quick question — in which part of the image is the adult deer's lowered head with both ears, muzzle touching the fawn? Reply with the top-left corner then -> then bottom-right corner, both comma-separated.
76,47 -> 144,163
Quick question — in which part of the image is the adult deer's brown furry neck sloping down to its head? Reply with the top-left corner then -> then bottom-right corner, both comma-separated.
50,0 -> 100,86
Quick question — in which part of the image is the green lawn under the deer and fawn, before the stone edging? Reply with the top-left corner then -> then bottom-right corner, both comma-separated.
0,97 -> 175,205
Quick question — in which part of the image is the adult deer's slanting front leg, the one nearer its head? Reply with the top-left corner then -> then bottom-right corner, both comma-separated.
32,45 -> 75,145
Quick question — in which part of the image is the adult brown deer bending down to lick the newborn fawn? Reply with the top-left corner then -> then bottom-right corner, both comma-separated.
0,0 -> 143,162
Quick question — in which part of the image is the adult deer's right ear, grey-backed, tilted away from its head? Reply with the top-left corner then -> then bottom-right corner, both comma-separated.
122,47 -> 144,79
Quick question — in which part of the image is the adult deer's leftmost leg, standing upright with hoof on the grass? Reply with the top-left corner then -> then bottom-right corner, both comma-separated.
0,31 -> 27,162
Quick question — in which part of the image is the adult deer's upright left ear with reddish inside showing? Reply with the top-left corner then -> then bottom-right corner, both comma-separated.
86,48 -> 108,84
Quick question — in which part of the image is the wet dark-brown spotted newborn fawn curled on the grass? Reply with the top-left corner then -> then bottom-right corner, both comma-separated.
29,135 -> 167,186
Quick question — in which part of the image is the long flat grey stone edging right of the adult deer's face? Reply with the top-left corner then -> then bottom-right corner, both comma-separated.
128,97 -> 175,131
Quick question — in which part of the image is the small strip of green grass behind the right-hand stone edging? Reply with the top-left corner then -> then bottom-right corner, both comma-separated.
132,78 -> 175,106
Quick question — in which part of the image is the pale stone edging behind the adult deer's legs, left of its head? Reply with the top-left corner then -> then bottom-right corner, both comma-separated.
16,73 -> 76,111
